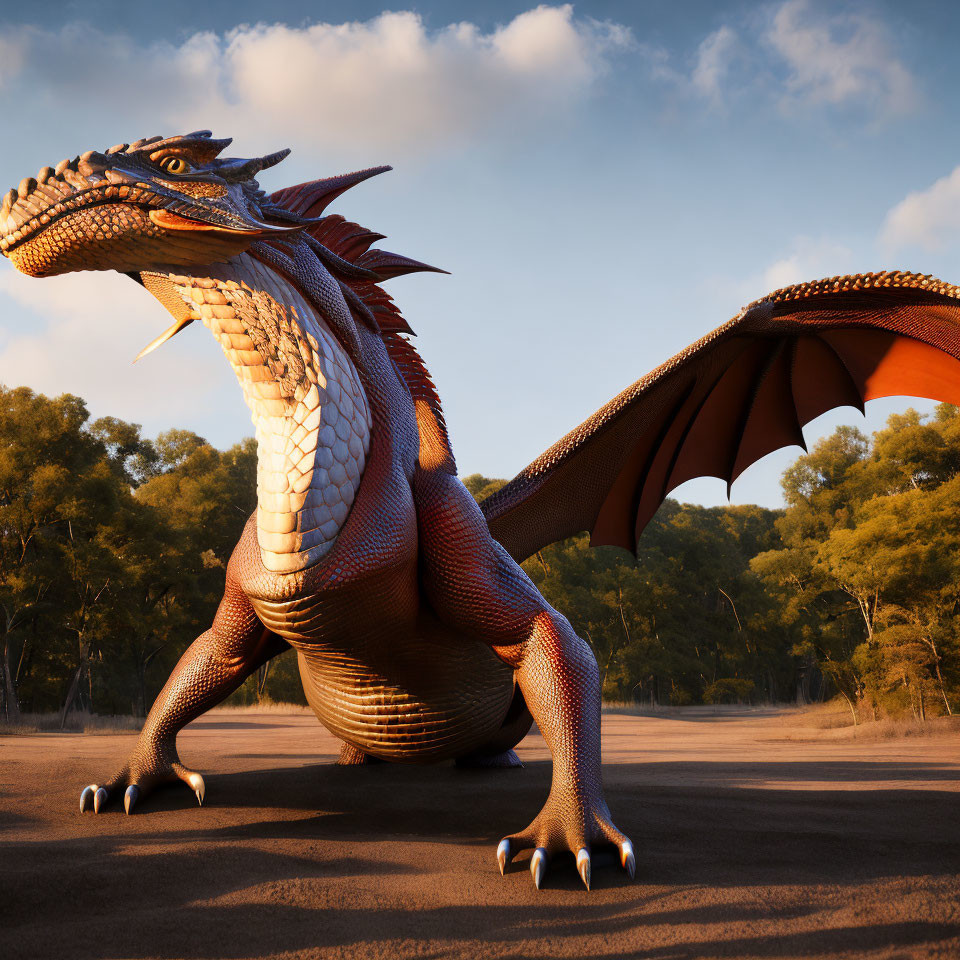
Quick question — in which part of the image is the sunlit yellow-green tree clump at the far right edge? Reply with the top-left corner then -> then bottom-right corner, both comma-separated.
751,405 -> 960,722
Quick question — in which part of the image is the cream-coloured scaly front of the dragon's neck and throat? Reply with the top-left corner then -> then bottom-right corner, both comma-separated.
141,254 -> 372,573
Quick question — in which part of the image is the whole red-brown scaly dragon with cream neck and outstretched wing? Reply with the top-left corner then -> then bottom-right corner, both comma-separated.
0,131 -> 960,889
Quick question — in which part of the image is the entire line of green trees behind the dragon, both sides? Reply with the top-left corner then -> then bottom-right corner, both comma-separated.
0,387 -> 960,722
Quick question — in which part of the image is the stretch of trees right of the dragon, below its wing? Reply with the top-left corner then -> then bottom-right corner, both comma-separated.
465,404 -> 960,723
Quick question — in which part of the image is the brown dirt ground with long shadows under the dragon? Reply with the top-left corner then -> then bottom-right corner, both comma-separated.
0,711 -> 960,960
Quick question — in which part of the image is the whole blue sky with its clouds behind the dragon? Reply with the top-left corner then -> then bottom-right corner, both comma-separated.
0,0 -> 960,505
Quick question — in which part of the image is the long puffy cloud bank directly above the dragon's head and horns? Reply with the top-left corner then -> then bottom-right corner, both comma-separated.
0,5 -> 632,156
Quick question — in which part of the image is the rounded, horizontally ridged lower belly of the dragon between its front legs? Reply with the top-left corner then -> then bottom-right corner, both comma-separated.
297,635 -> 513,763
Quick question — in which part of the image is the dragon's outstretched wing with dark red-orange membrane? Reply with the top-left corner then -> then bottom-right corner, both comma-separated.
481,272 -> 960,561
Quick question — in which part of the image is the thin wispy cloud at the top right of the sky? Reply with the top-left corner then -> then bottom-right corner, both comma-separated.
765,0 -> 917,115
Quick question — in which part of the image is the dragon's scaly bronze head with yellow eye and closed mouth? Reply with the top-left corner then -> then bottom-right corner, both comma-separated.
0,130 -> 302,277
